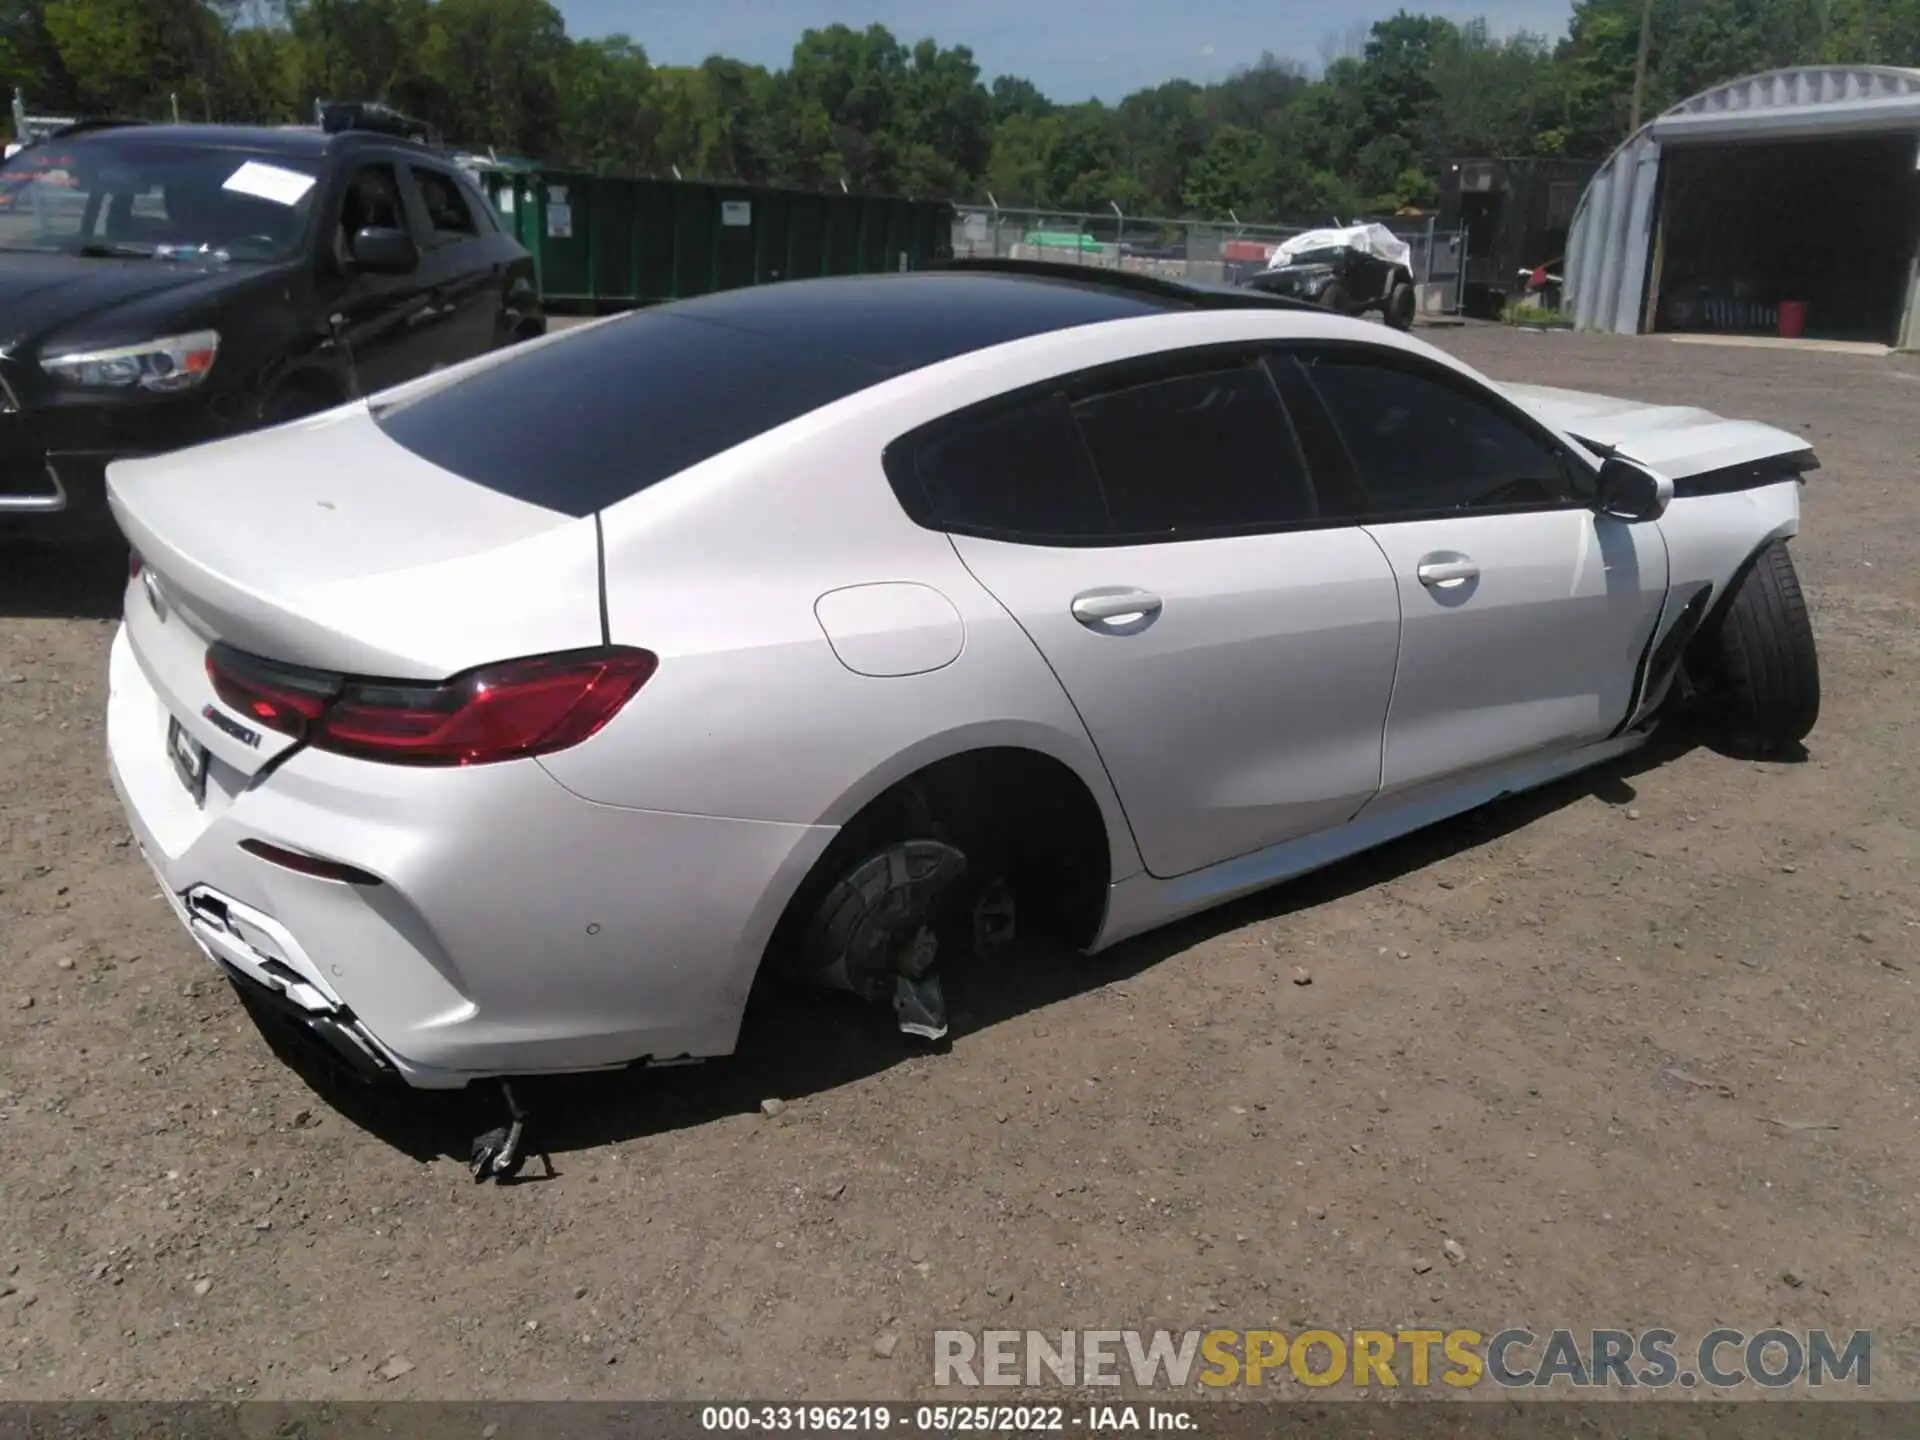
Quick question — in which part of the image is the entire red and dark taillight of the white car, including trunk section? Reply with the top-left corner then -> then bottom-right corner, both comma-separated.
207,645 -> 660,764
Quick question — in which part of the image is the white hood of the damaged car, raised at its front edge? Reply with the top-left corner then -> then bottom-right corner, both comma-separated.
1500,384 -> 1812,480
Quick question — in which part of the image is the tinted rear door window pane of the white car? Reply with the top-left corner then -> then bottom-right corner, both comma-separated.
1073,367 -> 1319,536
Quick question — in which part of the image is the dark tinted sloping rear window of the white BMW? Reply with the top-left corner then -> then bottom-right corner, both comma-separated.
376,311 -> 887,516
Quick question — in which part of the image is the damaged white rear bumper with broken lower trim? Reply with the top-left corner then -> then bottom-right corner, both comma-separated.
108,630 -> 835,1089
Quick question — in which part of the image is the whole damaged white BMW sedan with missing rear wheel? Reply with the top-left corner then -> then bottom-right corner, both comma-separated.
108,261 -> 1818,1171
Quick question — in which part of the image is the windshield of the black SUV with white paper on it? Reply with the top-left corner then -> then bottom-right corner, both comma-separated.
0,129 -> 319,261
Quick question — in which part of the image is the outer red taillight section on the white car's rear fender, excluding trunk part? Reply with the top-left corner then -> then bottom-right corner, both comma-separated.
309,649 -> 660,764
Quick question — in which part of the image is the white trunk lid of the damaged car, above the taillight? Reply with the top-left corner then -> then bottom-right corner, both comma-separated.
108,405 -> 601,774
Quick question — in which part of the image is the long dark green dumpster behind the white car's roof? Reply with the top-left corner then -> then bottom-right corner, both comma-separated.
470,169 -> 952,311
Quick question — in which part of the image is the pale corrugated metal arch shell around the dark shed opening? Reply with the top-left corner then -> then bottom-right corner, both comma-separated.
1567,65 -> 1920,334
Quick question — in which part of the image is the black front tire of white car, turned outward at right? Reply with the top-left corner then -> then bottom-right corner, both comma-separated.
1697,540 -> 1820,753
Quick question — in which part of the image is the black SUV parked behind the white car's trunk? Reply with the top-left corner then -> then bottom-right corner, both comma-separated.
0,108 -> 545,540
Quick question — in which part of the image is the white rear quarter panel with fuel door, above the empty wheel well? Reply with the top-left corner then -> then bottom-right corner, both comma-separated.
541,410 -> 1139,879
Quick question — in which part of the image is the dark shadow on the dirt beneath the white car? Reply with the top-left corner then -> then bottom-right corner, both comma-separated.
267,726 -> 1758,1179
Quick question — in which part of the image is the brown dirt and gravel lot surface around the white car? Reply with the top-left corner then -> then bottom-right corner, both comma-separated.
0,330 -> 1920,1398
